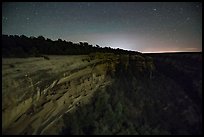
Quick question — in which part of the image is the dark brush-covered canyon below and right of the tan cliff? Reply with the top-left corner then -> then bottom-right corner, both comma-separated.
61,53 -> 202,135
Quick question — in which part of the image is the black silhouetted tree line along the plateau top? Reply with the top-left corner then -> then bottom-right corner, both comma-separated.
2,35 -> 139,57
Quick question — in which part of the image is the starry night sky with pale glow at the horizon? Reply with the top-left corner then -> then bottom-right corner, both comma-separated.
2,2 -> 202,52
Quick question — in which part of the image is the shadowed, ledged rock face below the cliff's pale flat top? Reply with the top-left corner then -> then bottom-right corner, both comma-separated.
2,53 -> 153,134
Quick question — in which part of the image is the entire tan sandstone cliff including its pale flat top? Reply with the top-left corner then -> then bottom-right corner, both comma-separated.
2,53 -> 153,134
